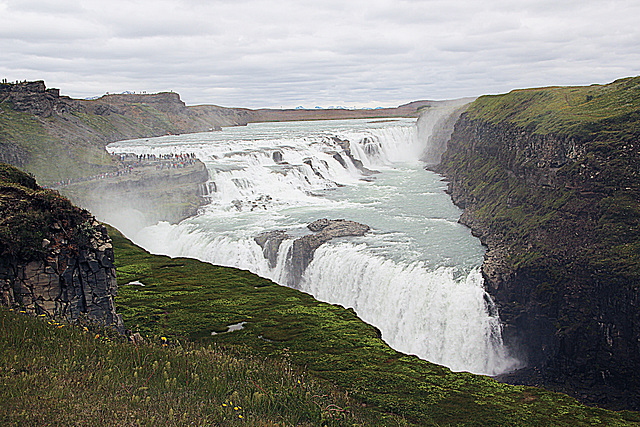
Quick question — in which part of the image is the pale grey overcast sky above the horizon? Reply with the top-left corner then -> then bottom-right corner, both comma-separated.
0,0 -> 640,108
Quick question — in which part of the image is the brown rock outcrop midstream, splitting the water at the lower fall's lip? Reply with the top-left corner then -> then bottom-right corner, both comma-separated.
254,218 -> 370,287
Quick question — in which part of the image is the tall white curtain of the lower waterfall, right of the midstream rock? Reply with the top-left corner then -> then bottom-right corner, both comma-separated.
302,243 -> 512,375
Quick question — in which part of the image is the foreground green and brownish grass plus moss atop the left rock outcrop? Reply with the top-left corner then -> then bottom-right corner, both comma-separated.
0,167 -> 640,426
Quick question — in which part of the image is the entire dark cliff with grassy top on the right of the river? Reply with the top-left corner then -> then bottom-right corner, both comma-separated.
434,78 -> 640,410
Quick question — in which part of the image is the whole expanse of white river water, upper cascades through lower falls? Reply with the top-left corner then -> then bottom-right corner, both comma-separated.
108,114 -> 517,374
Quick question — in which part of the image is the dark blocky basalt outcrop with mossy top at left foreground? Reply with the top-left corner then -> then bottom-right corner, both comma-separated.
0,165 -> 123,329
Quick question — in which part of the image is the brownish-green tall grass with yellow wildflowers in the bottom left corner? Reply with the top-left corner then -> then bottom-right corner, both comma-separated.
0,308 -> 390,427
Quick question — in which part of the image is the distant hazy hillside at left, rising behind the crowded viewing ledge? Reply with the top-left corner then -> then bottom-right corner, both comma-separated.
0,81 -> 250,184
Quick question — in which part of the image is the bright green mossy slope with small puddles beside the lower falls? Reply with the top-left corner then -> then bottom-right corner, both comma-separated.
110,226 -> 640,426
